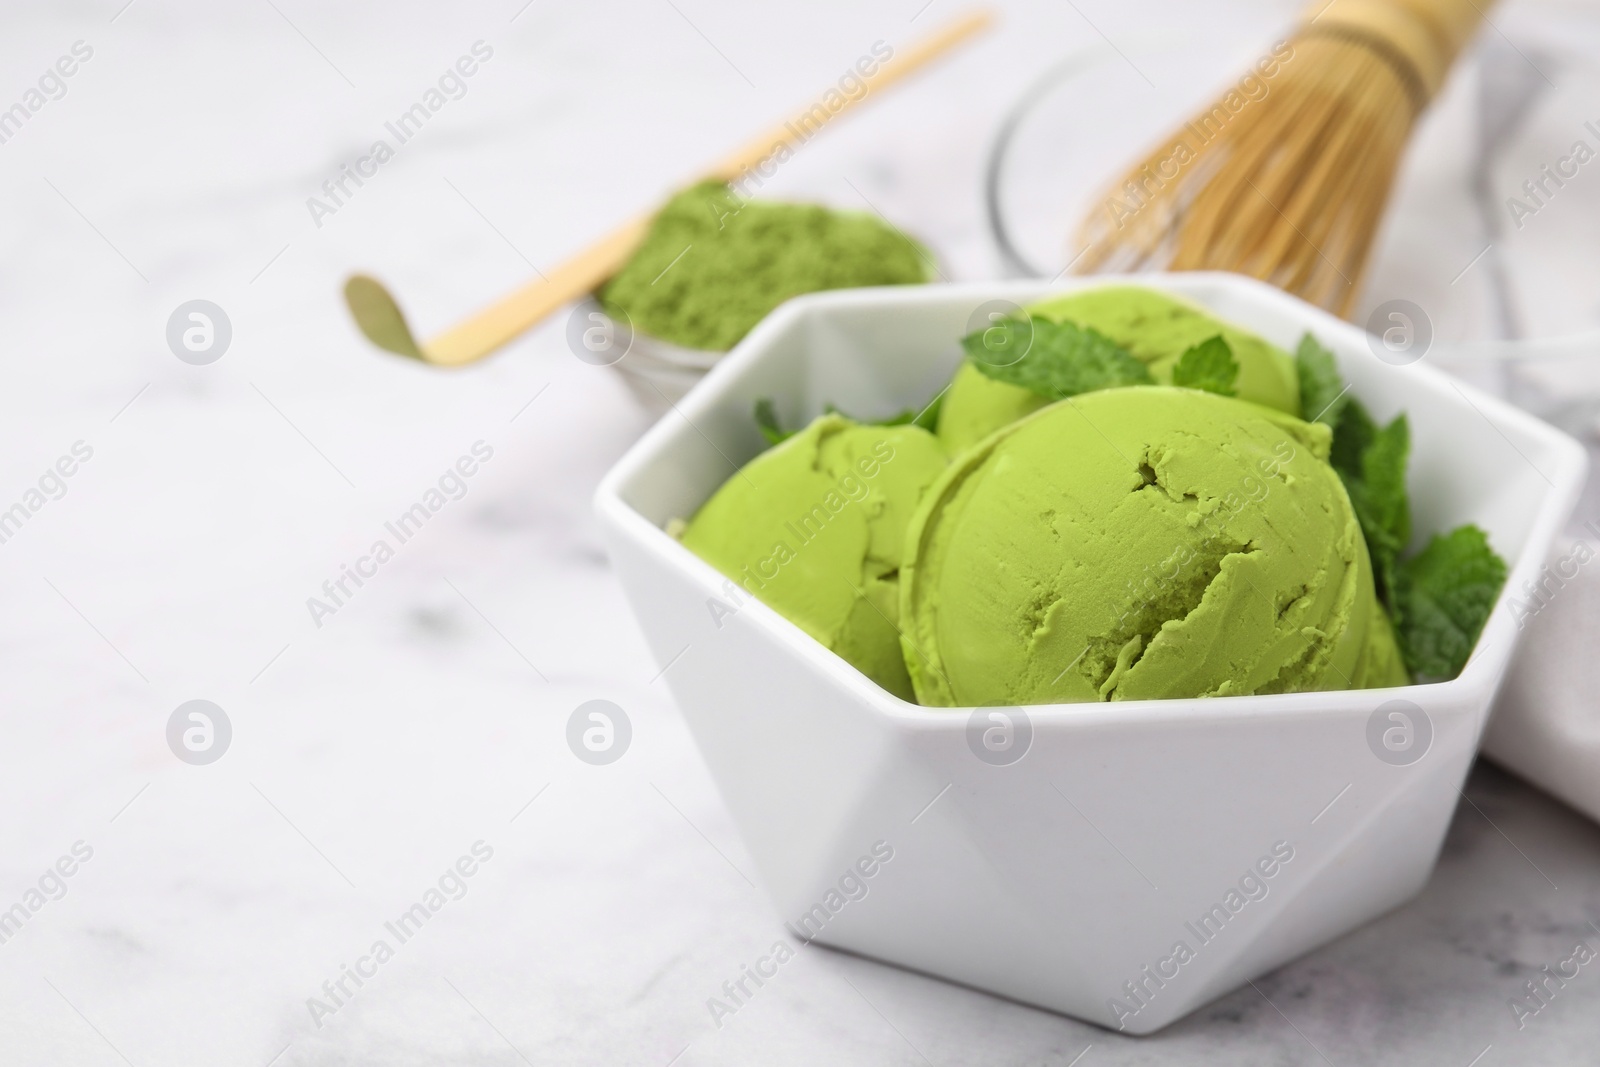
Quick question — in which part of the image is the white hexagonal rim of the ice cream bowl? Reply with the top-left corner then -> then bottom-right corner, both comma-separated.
594,270 -> 1589,731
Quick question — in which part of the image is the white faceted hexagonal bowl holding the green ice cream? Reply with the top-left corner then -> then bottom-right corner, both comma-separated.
597,274 -> 1586,1033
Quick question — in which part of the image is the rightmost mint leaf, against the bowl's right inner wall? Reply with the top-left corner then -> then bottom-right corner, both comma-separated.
1394,525 -> 1506,681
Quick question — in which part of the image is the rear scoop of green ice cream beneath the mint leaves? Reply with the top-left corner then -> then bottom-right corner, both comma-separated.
939,285 -> 1317,456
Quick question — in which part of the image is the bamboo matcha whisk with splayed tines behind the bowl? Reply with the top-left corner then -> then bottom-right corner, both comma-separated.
1074,0 -> 1493,315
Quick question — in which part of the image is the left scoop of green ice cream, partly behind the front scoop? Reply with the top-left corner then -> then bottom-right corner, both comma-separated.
683,414 -> 946,701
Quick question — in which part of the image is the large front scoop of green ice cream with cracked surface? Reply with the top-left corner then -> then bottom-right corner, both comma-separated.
901,385 -> 1405,705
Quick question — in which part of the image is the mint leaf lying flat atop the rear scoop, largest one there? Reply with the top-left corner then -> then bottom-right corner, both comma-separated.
962,318 -> 1155,400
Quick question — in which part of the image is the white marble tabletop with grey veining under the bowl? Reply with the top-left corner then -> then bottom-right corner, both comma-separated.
0,0 -> 1600,1067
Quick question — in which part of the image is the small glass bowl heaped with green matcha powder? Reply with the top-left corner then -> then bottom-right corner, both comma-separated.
594,182 -> 934,410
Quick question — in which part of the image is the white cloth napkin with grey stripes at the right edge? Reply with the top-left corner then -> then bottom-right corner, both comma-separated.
1355,0 -> 1600,821
